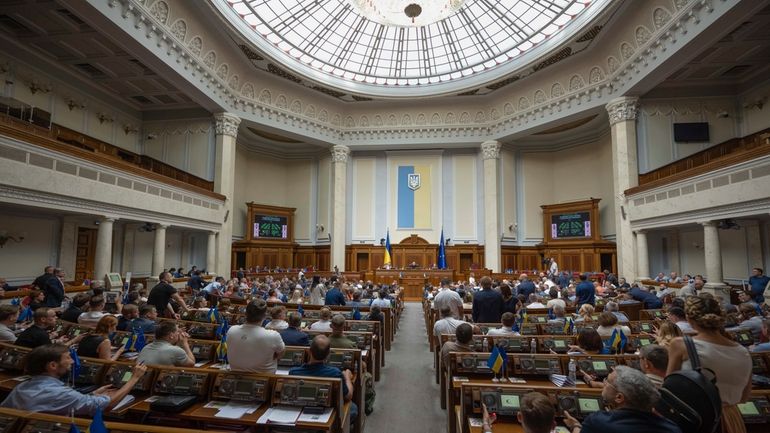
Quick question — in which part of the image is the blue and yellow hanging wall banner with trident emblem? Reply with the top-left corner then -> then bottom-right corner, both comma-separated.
397,165 -> 431,229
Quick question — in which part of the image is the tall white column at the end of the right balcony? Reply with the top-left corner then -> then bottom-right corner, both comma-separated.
606,97 -> 649,281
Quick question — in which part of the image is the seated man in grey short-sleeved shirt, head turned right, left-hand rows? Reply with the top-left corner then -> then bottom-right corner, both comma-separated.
136,322 -> 195,367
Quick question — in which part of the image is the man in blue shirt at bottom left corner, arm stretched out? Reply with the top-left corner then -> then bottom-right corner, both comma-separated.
0,344 -> 147,416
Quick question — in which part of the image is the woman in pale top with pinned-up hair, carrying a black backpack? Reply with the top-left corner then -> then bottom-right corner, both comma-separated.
667,294 -> 752,433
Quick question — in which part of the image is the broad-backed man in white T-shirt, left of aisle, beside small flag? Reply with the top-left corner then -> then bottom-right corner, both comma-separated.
227,299 -> 286,374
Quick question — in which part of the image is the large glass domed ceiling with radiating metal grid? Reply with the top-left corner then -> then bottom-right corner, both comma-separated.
211,0 -> 611,97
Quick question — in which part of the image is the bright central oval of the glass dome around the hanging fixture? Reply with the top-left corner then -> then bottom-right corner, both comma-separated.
348,0 -> 465,27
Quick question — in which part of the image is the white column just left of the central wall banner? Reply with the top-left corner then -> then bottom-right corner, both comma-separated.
329,144 -> 350,271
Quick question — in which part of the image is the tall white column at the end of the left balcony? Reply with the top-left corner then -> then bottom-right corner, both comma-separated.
213,113 -> 243,275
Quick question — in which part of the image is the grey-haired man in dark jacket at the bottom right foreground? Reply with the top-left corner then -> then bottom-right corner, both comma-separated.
564,365 -> 682,433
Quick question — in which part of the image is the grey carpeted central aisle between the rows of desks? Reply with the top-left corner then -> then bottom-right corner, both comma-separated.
364,302 -> 446,433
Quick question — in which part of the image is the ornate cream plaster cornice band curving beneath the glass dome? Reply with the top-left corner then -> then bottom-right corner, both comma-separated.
102,0 -> 738,145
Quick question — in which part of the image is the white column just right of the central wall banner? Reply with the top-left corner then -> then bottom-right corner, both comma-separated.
481,140 -> 501,272
